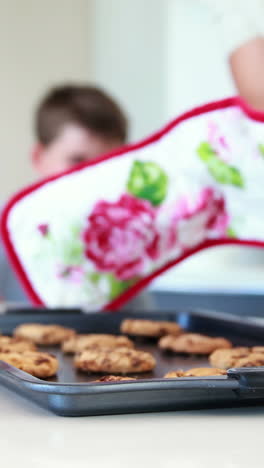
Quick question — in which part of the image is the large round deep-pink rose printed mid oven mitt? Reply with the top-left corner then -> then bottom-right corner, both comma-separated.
83,194 -> 158,280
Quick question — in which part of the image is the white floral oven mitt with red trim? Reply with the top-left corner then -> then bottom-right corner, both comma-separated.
1,98 -> 264,310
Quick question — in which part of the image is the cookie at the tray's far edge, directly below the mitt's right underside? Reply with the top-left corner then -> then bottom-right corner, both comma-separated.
120,319 -> 183,338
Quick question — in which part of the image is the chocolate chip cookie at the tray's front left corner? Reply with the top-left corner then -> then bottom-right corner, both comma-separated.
0,351 -> 59,379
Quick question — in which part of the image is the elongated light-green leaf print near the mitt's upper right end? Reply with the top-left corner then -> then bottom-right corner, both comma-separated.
197,142 -> 244,188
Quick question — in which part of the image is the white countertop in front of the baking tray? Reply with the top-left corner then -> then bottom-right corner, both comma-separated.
0,388 -> 264,468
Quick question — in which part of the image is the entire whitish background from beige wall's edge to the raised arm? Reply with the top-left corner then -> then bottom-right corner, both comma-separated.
90,0 -> 235,133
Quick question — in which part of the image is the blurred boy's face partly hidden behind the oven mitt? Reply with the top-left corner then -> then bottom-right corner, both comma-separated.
32,124 -> 122,177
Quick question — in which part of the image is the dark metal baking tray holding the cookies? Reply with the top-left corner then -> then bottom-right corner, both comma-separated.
0,308 -> 264,416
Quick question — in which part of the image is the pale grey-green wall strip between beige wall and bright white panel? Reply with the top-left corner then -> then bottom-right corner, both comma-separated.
91,0 -> 167,140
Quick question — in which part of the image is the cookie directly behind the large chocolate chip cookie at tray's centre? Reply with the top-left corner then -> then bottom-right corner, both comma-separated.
62,333 -> 134,354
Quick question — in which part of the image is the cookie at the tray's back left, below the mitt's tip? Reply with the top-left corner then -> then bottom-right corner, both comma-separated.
14,323 -> 76,346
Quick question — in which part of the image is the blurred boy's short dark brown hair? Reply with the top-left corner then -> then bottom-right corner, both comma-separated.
35,84 -> 128,145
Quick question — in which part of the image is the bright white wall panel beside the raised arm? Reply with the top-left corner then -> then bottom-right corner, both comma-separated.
164,0 -> 235,117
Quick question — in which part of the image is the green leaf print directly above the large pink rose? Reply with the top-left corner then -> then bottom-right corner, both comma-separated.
127,161 -> 168,206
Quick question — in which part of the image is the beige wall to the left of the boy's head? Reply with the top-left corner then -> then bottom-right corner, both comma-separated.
0,0 -> 90,199
